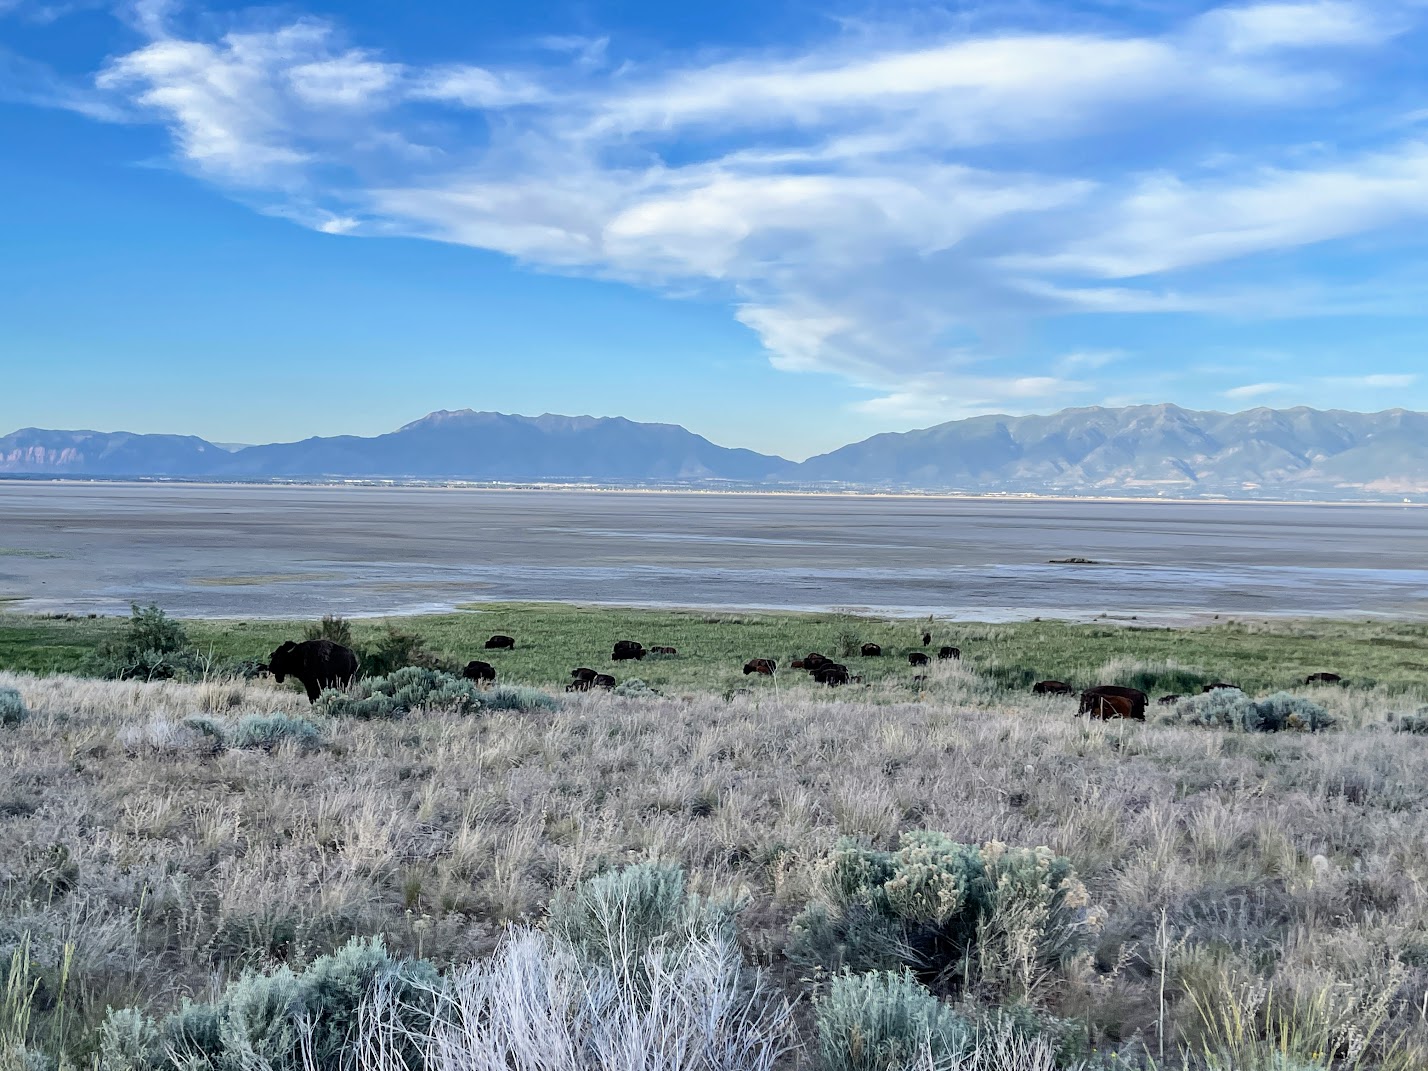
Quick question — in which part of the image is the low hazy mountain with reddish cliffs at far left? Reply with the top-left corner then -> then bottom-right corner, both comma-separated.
0,427 -> 230,476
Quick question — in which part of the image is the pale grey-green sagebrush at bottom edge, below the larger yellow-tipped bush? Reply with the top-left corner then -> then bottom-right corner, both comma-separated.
814,971 -> 971,1071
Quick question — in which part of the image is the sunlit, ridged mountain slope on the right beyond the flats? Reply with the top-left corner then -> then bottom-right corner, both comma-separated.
800,406 -> 1428,496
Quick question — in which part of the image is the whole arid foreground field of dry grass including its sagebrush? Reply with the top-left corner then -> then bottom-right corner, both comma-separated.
0,611 -> 1428,1071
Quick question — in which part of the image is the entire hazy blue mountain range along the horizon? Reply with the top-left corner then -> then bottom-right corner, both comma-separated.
0,404 -> 1428,500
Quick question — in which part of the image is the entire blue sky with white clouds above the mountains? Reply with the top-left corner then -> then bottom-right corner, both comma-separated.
0,0 -> 1428,457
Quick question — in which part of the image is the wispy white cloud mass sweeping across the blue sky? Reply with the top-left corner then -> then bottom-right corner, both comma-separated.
11,0 -> 1428,418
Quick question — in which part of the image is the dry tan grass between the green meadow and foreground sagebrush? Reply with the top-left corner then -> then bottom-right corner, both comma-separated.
0,665 -> 1428,1068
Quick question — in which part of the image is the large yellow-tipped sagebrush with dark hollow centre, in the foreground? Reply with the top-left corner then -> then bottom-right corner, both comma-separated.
790,831 -> 1095,997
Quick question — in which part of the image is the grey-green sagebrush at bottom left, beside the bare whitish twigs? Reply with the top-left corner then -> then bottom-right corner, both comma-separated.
100,938 -> 437,1071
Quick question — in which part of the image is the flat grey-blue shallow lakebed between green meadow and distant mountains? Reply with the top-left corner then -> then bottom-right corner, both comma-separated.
0,481 -> 1428,621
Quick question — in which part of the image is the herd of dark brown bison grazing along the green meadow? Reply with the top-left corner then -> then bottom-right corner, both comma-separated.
260,633 -> 1344,721
